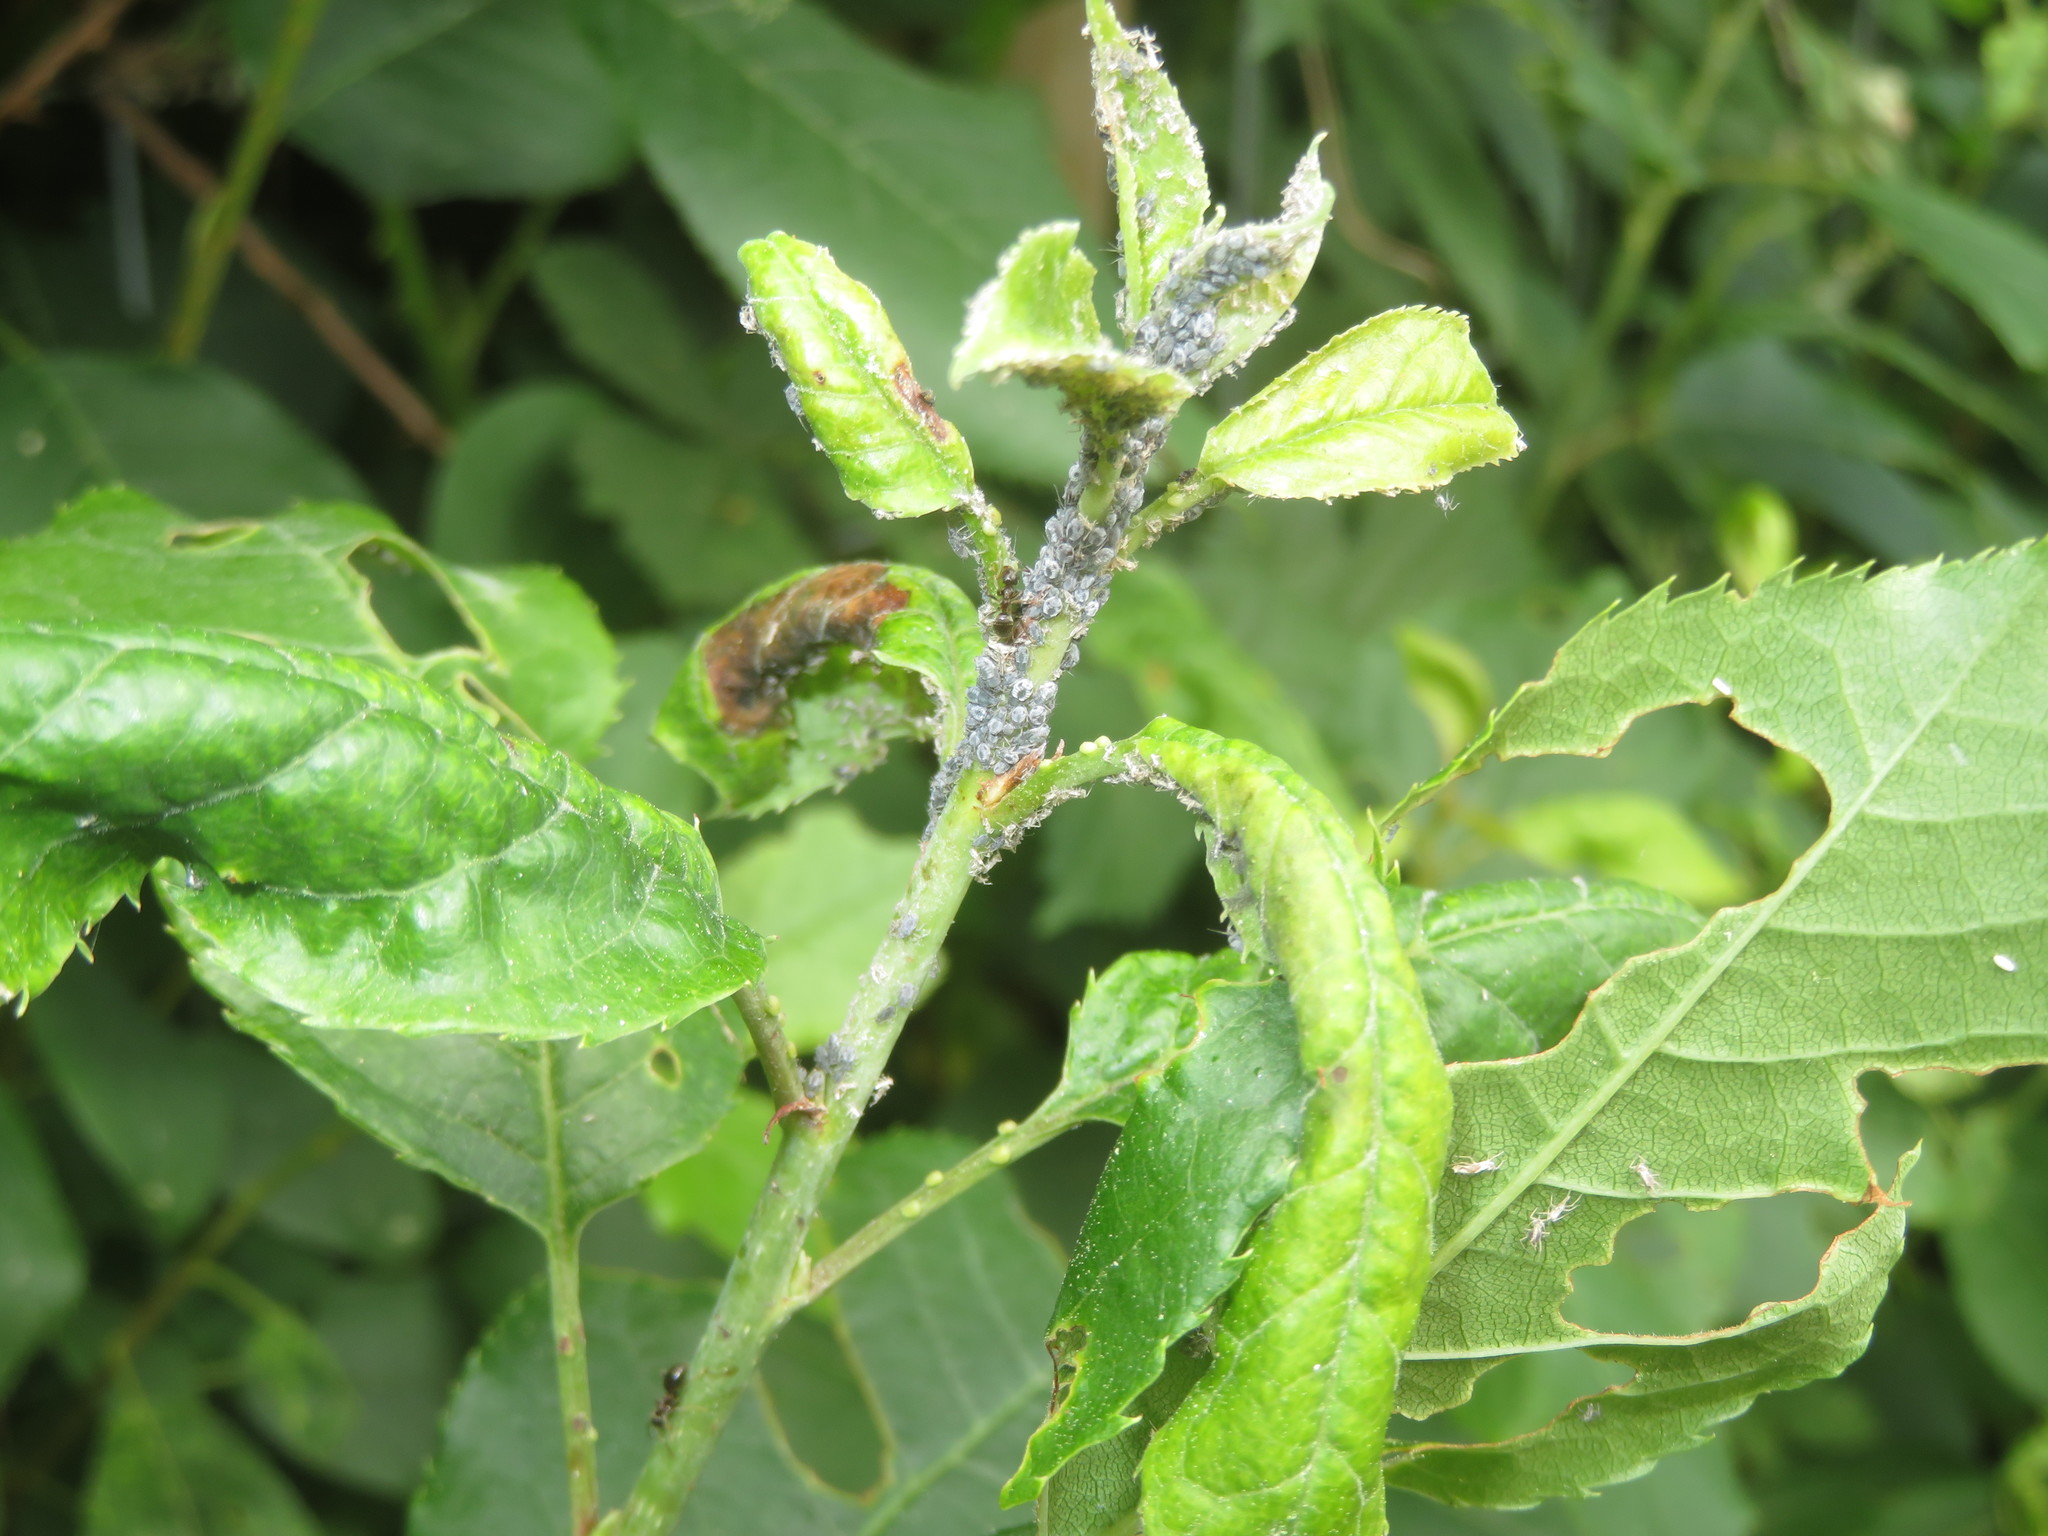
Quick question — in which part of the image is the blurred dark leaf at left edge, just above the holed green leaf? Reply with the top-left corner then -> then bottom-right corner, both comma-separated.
0,352 -> 362,535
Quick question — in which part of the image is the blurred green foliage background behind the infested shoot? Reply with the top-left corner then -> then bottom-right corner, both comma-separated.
0,0 -> 2048,1536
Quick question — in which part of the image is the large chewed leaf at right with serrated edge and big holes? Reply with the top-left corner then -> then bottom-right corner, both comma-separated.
1397,545 -> 2048,1507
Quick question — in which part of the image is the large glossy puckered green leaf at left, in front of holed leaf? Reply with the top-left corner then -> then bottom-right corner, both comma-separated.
0,623 -> 760,1040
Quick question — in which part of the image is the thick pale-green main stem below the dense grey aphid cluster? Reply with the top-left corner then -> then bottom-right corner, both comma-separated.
600,772 -> 987,1536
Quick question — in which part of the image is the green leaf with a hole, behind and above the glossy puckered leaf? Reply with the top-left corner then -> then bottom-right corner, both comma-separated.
0,489 -> 621,756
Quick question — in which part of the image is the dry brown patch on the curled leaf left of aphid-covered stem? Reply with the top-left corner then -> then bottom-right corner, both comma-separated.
705,561 -> 909,735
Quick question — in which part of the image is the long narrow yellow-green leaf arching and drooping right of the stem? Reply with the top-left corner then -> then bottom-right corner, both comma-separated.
989,721 -> 1450,1536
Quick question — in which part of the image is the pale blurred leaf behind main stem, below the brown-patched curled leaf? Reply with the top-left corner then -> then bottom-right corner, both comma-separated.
721,805 -> 918,1051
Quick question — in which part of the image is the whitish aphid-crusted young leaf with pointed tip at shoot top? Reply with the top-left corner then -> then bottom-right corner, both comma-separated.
1130,139 -> 1337,389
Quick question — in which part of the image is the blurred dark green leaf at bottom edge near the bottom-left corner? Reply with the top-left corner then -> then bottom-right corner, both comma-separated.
80,1374 -> 319,1536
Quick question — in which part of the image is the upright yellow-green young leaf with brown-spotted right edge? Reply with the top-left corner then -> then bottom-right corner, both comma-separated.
739,233 -> 975,518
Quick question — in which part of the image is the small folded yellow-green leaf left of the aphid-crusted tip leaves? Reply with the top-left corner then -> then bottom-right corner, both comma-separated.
950,223 -> 1194,422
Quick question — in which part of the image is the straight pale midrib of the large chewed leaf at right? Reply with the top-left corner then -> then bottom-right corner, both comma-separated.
1430,602 -> 2023,1280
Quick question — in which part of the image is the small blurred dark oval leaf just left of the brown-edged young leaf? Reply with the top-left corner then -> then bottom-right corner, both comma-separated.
532,240 -> 719,430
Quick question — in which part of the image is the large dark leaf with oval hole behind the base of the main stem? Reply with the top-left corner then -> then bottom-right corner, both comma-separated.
410,1133 -> 1059,1536
